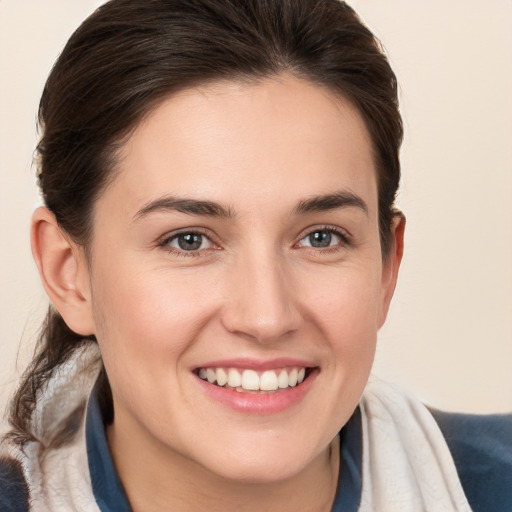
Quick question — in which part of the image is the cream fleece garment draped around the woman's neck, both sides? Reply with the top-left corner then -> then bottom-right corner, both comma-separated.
1,343 -> 471,512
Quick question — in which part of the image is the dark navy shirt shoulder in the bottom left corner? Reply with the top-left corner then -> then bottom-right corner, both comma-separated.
0,457 -> 29,512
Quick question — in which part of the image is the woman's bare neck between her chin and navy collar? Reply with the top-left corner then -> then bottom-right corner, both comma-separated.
107,416 -> 340,512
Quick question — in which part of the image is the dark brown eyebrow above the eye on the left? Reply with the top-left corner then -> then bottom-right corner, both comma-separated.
133,196 -> 235,221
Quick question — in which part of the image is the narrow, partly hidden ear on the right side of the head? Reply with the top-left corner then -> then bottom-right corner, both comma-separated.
378,212 -> 405,329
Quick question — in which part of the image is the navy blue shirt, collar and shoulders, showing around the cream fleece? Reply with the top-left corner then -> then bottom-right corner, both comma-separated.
0,394 -> 512,512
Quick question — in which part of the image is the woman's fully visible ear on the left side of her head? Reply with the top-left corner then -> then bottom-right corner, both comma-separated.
30,208 -> 94,336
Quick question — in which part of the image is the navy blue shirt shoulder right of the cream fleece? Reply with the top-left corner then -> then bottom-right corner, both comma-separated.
430,410 -> 512,512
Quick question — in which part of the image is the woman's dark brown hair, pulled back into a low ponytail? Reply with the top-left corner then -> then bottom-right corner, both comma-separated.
6,0 -> 402,443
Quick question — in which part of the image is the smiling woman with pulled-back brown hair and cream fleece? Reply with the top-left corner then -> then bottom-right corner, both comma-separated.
1,0 -> 512,511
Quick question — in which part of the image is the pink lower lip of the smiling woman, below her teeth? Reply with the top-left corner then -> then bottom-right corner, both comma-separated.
196,369 -> 318,414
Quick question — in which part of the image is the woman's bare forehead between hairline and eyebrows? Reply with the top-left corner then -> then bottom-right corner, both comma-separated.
102,75 -> 377,219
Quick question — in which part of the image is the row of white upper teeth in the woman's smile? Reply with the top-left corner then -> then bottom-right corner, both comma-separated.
198,368 -> 306,392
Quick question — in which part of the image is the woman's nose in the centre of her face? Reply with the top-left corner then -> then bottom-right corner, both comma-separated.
222,249 -> 303,343
